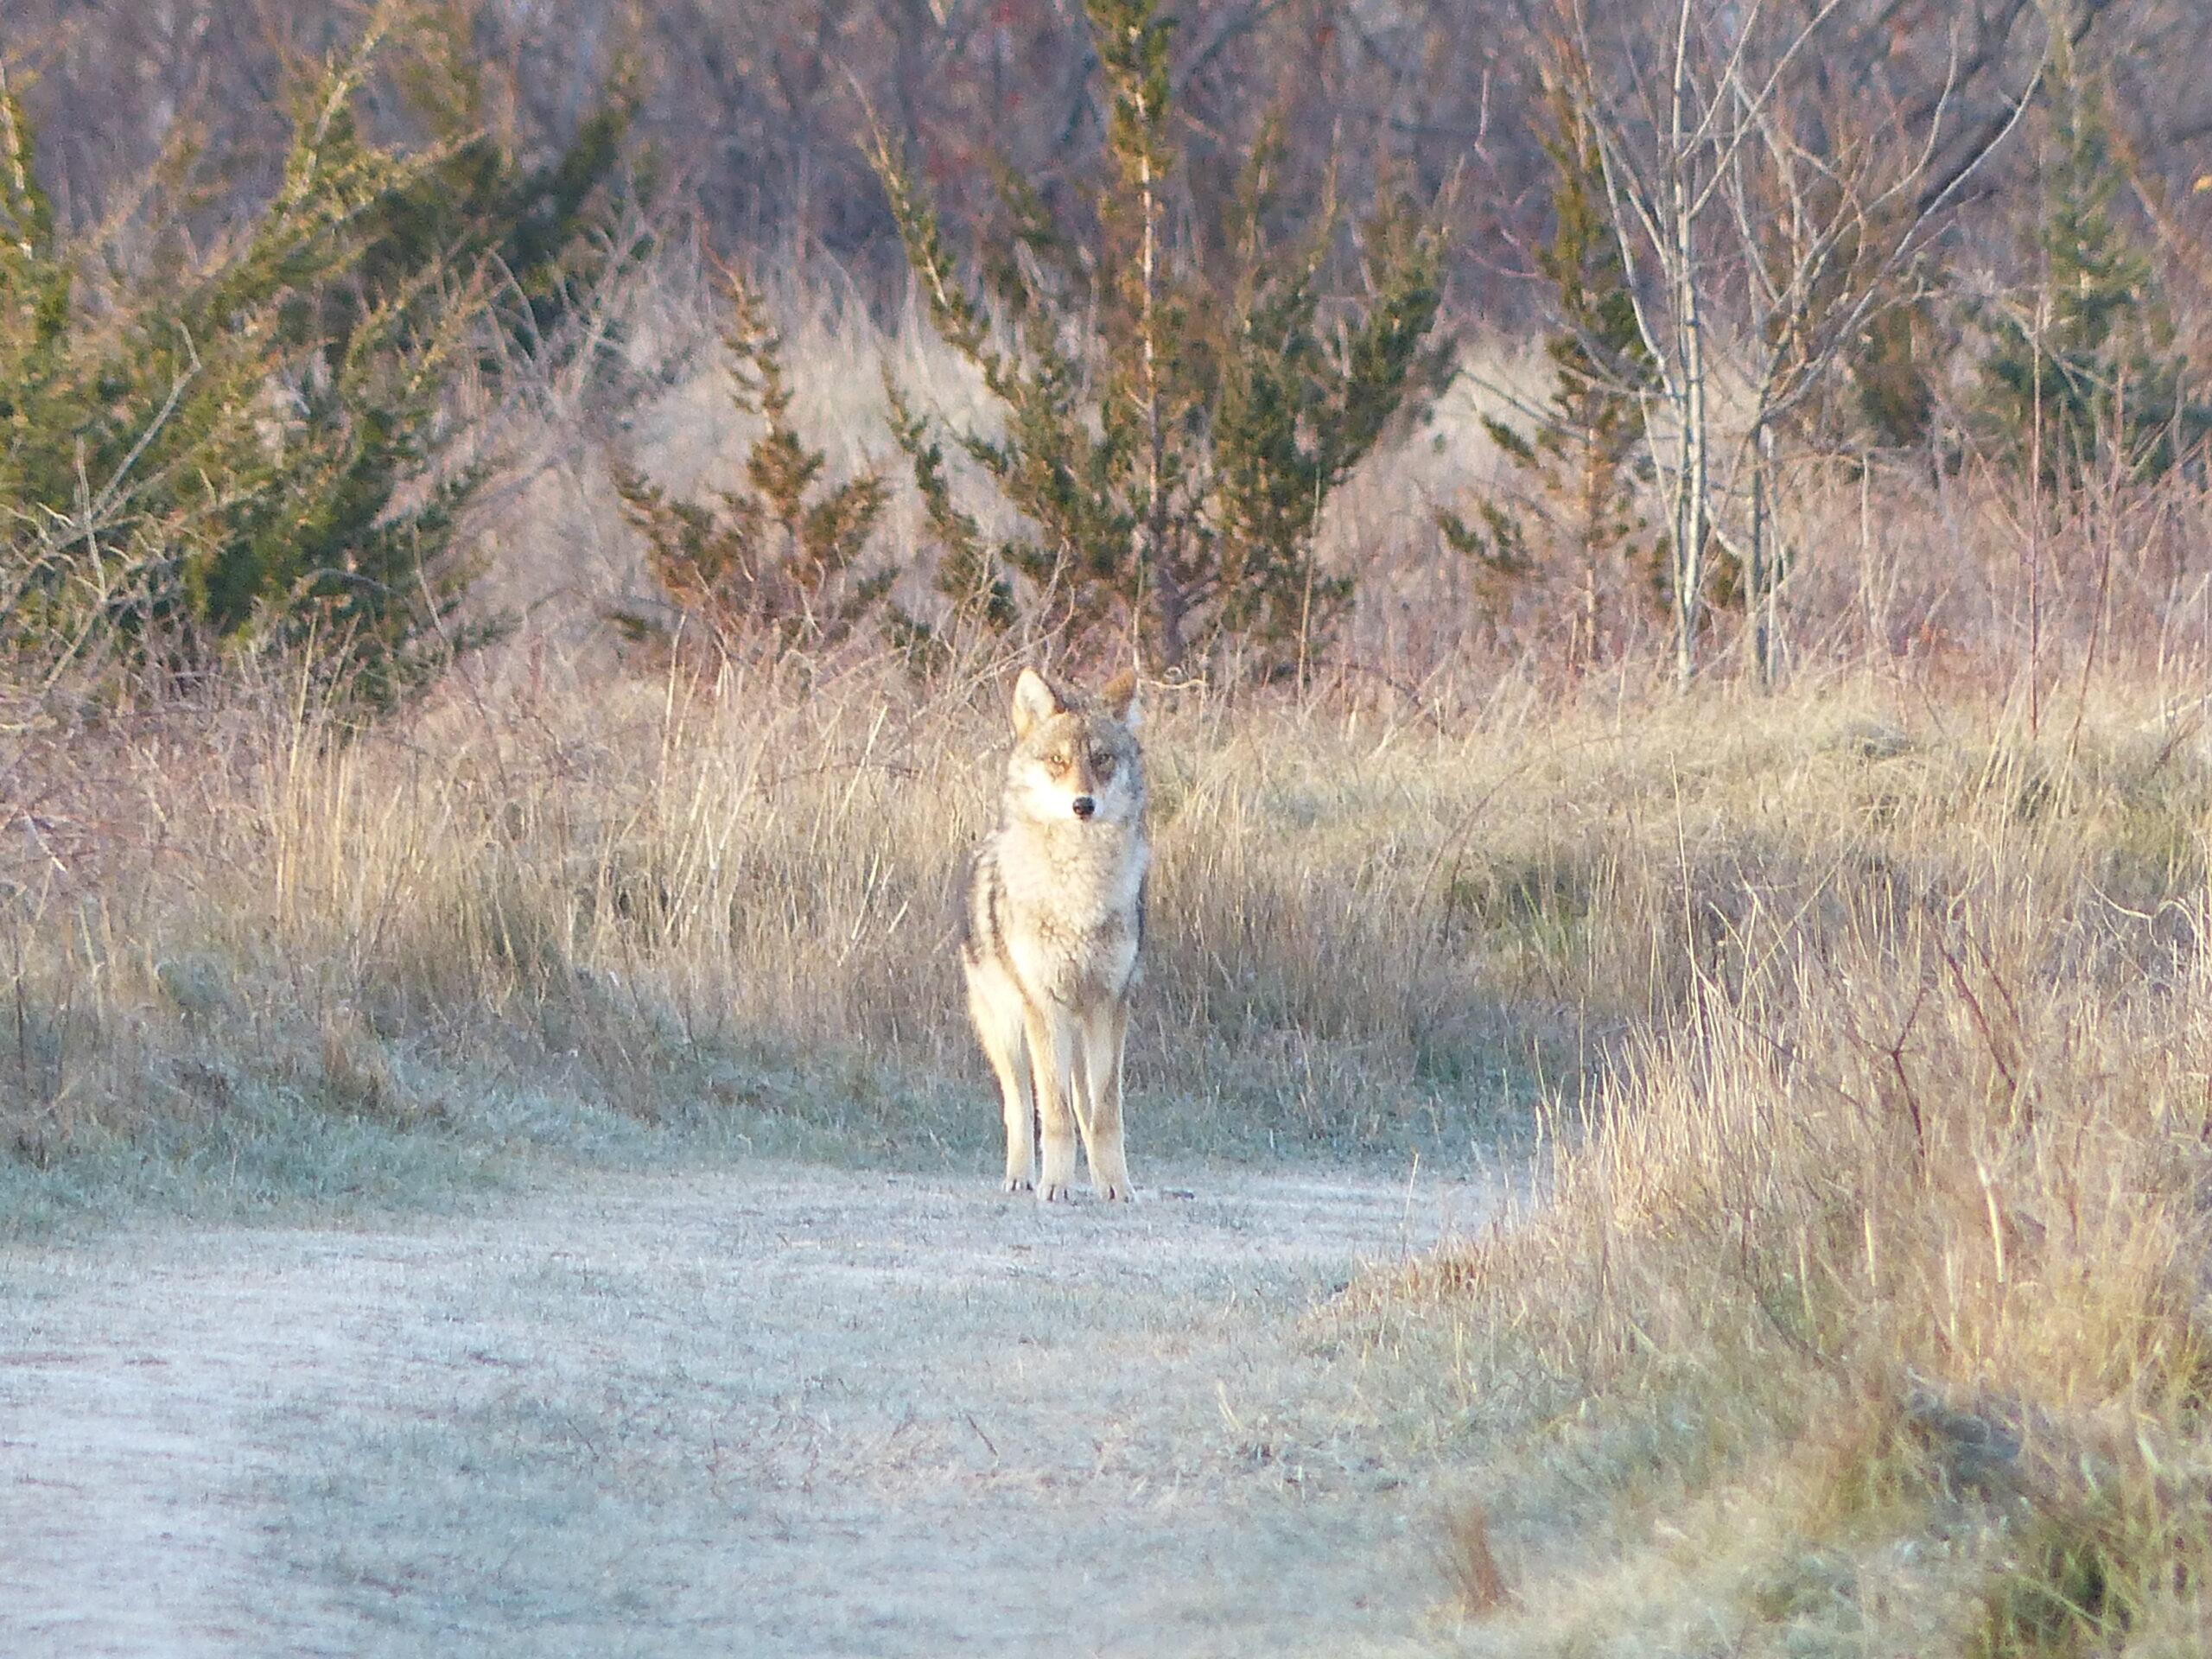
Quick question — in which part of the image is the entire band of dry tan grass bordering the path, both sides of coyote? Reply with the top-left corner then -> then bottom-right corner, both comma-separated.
26,623 -> 2212,1655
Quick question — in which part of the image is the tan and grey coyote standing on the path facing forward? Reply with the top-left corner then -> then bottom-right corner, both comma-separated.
960,668 -> 1153,1201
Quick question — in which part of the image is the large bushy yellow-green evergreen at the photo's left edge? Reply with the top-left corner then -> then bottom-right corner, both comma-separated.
0,17 -> 641,706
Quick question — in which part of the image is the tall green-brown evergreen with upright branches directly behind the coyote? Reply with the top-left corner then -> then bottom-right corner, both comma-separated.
872,0 -> 1440,672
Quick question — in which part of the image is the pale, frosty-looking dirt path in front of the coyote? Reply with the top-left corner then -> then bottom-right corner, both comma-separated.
0,1166 -> 1484,1659
